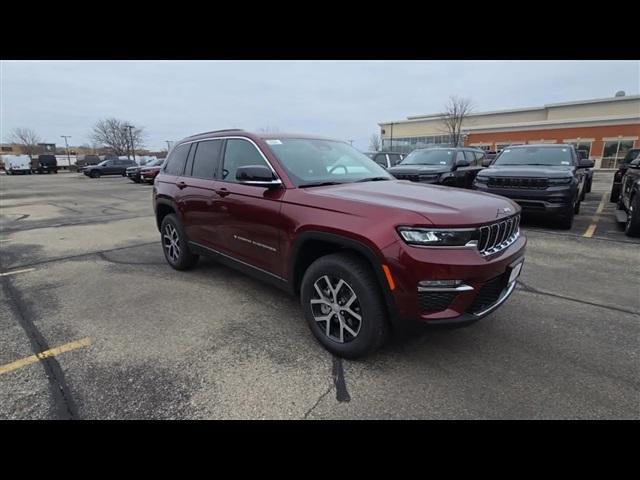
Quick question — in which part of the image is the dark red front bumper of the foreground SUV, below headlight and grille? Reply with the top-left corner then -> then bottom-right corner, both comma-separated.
382,234 -> 527,325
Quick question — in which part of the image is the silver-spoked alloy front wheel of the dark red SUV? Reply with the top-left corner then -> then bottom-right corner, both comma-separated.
310,275 -> 362,343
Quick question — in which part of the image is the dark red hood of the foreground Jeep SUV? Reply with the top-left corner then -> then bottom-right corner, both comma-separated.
305,180 -> 520,226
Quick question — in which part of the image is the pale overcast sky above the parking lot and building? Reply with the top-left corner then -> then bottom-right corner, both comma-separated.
0,61 -> 640,150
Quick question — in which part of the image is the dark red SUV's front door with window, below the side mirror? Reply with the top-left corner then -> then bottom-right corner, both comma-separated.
215,138 -> 285,277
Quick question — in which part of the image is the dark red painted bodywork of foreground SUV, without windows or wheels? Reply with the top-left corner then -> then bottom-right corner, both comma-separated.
154,132 -> 526,321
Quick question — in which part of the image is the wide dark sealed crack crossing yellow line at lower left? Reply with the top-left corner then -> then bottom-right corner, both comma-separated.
2,277 -> 79,420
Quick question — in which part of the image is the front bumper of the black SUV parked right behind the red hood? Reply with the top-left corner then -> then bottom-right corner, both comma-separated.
473,183 -> 576,215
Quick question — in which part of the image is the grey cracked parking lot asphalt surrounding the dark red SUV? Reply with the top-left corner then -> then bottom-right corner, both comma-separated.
0,172 -> 640,419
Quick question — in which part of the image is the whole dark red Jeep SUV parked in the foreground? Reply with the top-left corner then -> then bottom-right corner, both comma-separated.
153,130 -> 526,358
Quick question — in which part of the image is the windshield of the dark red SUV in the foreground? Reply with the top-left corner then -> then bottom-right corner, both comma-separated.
265,138 -> 393,187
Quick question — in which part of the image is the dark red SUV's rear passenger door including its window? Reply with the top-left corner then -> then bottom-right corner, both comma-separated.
181,139 -> 224,244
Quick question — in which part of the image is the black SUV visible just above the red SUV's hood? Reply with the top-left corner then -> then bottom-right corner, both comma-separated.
388,147 -> 489,188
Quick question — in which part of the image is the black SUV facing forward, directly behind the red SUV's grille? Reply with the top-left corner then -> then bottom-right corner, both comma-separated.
473,144 -> 593,229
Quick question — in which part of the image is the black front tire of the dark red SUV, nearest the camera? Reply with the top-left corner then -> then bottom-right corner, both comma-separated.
300,252 -> 389,359
